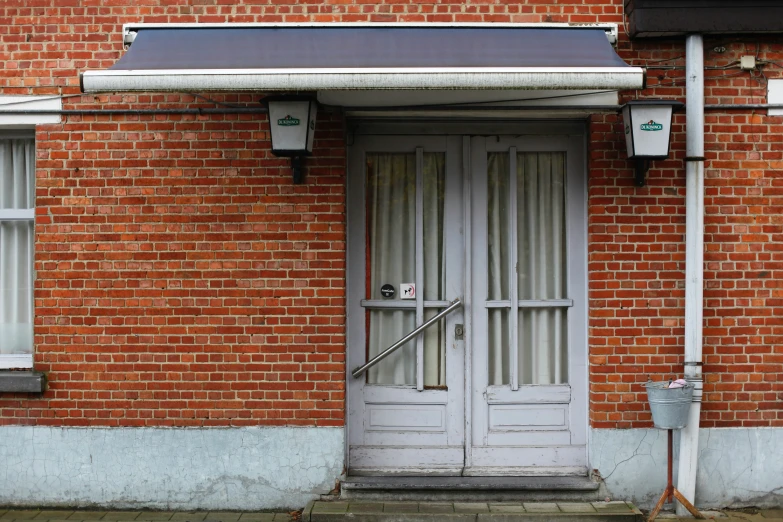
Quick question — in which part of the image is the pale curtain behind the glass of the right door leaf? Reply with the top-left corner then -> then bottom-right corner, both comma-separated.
487,148 -> 568,385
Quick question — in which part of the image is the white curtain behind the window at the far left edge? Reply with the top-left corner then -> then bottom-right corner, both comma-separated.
0,139 -> 35,354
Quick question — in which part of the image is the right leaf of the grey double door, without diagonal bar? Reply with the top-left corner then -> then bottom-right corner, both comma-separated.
465,135 -> 588,475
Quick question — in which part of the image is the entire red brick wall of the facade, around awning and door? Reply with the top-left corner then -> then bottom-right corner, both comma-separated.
0,0 -> 783,428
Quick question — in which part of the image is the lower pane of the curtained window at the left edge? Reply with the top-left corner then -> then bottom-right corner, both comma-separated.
0,221 -> 33,354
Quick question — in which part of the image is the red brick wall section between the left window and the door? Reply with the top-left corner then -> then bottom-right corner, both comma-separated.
0,95 -> 345,426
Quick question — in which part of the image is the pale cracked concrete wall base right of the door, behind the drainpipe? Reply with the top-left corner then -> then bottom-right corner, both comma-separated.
590,428 -> 783,508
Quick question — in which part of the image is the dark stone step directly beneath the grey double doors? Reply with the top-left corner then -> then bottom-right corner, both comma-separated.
340,476 -> 606,502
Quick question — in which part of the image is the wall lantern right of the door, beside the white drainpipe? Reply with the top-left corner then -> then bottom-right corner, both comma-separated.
623,100 -> 685,187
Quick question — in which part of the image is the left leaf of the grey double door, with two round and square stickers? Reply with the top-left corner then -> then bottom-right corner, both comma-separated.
347,135 -> 465,475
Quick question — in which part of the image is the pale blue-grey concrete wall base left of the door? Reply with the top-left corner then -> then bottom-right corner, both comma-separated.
0,426 -> 345,510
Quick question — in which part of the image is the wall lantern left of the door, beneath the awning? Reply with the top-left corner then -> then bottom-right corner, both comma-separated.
261,96 -> 318,184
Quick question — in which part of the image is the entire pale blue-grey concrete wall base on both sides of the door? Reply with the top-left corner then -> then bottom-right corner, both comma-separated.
0,426 -> 783,510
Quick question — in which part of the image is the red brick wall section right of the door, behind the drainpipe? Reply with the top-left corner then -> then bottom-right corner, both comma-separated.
589,37 -> 783,428
